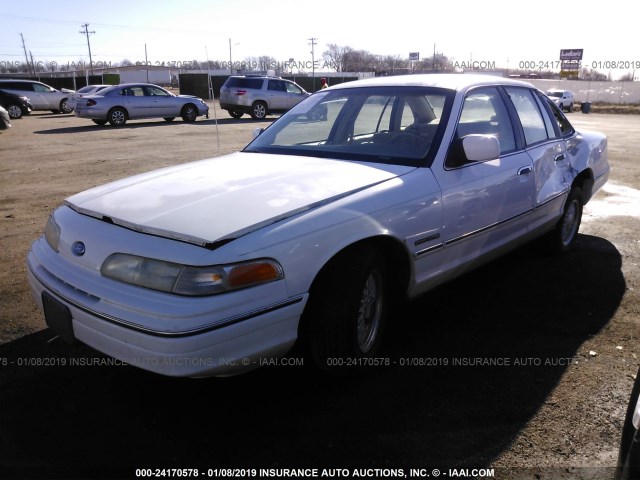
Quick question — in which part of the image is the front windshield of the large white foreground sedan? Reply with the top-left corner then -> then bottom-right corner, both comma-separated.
244,87 -> 453,166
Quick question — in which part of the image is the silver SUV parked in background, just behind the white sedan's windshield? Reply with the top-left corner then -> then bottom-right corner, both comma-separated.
220,75 -> 310,120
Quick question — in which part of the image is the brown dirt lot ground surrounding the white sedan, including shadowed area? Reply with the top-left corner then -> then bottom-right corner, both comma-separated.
0,107 -> 640,479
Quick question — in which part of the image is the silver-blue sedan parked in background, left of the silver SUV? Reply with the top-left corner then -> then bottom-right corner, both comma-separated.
76,83 -> 209,126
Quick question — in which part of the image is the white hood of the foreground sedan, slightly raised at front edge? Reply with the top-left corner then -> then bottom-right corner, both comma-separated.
65,152 -> 414,248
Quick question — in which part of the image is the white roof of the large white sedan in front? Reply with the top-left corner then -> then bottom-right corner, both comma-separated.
329,73 -> 535,91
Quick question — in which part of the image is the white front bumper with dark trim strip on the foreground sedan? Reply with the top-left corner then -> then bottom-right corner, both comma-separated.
27,242 -> 307,377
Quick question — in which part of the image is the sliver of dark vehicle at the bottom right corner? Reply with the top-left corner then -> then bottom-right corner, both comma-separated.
615,370 -> 640,480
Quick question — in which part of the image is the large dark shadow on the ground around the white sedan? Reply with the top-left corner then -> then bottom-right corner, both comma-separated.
0,235 -> 625,478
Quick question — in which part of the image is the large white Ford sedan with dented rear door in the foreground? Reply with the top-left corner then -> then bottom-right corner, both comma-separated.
28,75 -> 609,377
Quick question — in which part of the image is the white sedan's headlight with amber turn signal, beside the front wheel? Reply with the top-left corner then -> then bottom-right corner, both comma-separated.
100,253 -> 284,296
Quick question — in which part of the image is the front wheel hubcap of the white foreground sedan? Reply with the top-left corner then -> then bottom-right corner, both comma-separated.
357,270 -> 383,353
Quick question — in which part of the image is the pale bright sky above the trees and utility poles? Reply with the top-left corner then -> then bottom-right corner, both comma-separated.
0,0 -> 640,78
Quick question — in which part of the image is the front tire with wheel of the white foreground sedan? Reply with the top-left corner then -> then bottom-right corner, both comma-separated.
301,249 -> 391,373
